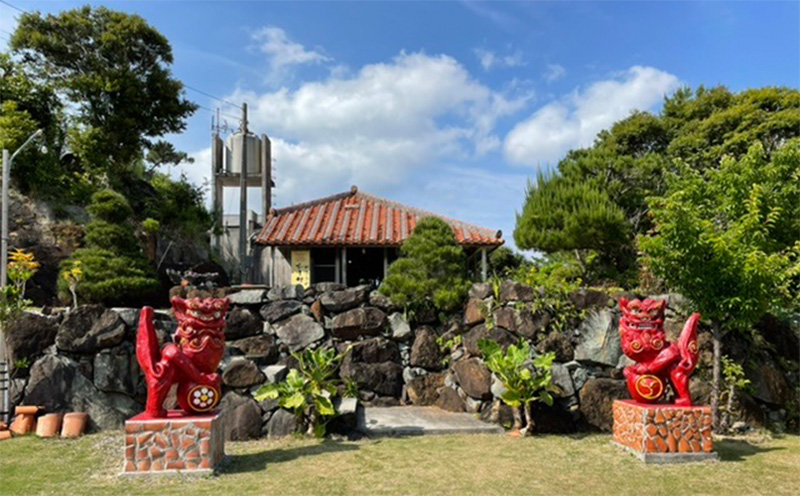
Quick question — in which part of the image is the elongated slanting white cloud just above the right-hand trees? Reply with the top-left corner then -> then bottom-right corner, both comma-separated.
503,66 -> 679,166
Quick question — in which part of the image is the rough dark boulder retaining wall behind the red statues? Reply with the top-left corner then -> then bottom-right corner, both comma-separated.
7,281 -> 797,440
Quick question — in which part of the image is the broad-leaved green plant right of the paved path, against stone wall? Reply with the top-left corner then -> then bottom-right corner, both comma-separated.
478,339 -> 558,435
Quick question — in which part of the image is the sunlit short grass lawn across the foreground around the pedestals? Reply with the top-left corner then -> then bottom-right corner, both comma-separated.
0,432 -> 800,496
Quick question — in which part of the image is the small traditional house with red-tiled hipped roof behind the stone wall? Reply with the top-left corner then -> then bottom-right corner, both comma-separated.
255,186 -> 503,286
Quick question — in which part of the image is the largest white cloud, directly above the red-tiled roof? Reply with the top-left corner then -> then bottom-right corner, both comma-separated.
182,53 -> 532,212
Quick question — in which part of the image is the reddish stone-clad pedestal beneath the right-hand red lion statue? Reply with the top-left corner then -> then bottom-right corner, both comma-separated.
614,400 -> 717,463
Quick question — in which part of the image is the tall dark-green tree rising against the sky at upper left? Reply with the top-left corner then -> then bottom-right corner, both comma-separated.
11,6 -> 197,180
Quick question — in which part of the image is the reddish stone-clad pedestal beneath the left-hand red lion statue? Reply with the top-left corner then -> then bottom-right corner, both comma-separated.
123,410 -> 225,475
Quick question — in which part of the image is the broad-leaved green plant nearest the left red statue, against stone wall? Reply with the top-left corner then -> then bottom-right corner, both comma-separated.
254,348 -> 352,437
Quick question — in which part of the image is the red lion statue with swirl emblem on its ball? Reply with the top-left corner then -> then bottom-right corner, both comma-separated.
619,298 -> 700,406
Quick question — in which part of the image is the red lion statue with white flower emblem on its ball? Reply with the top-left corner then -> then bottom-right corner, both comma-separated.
136,297 -> 229,419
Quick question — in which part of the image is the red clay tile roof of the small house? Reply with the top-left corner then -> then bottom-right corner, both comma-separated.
256,186 -> 503,247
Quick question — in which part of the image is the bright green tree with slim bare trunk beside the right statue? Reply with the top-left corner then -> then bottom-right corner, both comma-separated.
639,139 -> 800,425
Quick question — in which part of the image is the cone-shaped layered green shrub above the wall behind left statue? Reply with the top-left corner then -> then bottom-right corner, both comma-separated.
58,190 -> 159,306
